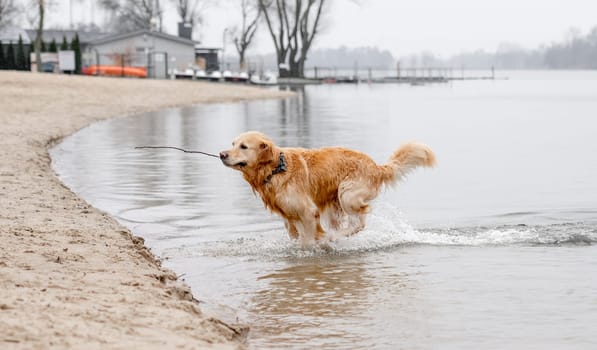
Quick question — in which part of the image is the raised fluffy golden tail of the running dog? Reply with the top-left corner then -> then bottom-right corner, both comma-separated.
380,142 -> 436,185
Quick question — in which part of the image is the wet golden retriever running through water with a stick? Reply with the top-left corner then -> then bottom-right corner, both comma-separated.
220,131 -> 435,247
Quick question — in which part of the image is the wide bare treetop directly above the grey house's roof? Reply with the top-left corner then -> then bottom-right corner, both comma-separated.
100,0 -> 164,32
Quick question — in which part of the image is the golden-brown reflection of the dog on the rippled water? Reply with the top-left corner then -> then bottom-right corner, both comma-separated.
250,259 -> 377,349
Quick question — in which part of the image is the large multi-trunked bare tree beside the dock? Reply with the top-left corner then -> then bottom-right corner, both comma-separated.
259,0 -> 326,77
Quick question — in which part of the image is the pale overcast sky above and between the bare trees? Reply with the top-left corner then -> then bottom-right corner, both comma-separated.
43,0 -> 597,57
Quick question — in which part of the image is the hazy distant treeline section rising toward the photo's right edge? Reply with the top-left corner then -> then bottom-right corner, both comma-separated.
400,27 -> 597,69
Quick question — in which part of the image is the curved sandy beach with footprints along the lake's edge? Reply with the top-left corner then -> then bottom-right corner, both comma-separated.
0,71 -> 288,349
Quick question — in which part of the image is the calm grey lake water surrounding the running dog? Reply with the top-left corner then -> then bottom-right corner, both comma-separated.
51,72 -> 597,349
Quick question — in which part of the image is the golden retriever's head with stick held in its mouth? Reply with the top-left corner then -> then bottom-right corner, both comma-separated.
220,131 -> 274,172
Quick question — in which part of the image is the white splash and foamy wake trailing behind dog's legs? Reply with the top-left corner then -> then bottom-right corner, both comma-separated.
164,205 -> 597,259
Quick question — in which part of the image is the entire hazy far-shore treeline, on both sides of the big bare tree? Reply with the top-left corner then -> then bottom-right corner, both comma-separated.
237,27 -> 597,71
